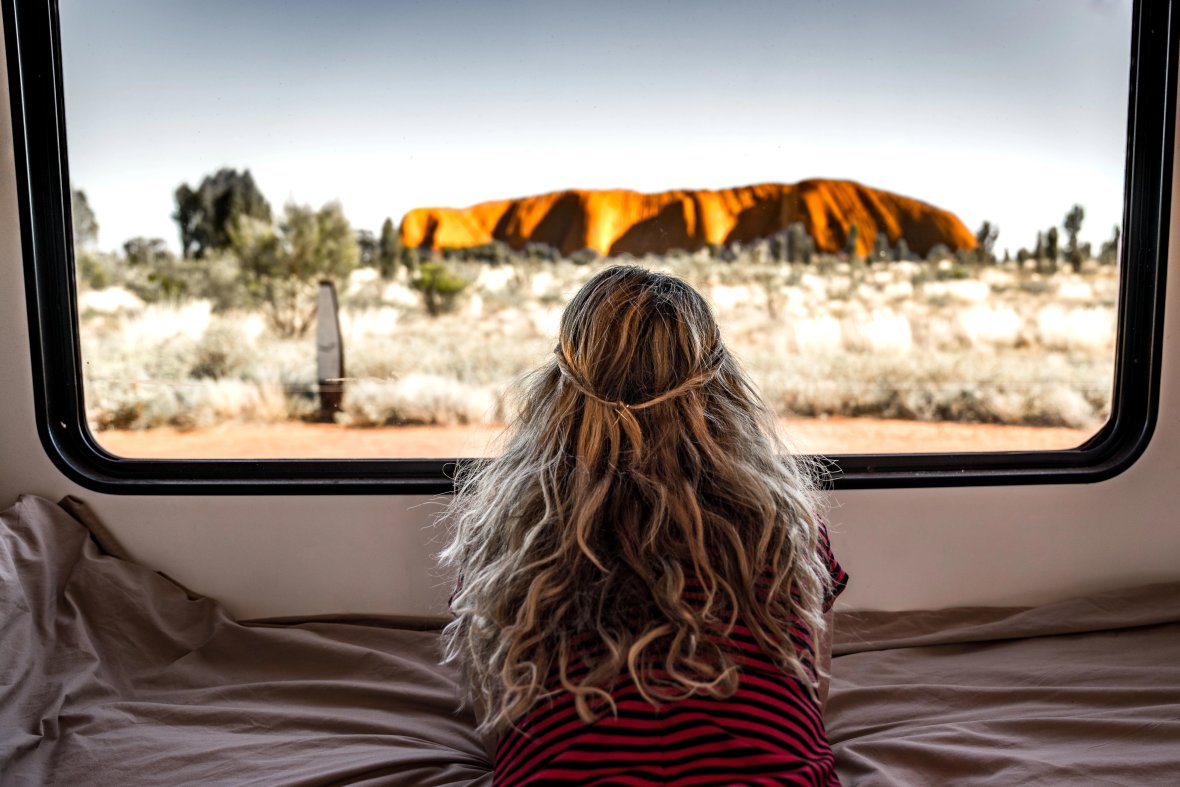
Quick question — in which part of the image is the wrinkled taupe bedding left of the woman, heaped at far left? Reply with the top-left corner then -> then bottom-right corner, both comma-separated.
0,497 -> 491,787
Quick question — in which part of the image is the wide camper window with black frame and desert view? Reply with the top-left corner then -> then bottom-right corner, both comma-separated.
5,0 -> 1175,491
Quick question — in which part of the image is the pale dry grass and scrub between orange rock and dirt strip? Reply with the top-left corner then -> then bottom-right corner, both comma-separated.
80,255 -> 1117,429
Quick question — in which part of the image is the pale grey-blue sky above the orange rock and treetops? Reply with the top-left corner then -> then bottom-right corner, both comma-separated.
60,0 -> 1130,254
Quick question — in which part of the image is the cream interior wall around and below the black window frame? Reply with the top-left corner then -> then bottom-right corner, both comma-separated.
0,30 -> 1180,617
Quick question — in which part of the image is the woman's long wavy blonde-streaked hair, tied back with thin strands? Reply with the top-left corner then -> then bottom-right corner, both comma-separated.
441,267 -> 831,733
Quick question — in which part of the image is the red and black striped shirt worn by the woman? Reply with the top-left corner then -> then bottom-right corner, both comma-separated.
494,529 -> 848,787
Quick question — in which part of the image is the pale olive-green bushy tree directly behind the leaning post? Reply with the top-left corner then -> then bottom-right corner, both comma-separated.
231,202 -> 360,336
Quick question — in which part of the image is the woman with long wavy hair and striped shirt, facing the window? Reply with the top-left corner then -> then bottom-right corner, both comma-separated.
444,267 -> 846,785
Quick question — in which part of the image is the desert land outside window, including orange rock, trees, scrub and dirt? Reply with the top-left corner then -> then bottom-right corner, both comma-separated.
78,171 -> 1119,458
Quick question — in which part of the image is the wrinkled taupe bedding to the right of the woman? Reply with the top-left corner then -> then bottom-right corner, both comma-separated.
826,584 -> 1180,786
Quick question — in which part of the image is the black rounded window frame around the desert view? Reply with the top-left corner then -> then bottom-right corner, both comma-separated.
2,0 -> 1180,494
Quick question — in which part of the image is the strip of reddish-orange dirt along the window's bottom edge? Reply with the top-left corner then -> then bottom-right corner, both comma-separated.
96,418 -> 1093,459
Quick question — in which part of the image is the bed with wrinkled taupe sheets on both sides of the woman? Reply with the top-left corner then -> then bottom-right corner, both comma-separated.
0,496 -> 1180,786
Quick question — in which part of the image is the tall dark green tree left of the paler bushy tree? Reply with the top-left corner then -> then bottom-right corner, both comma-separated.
172,168 -> 270,260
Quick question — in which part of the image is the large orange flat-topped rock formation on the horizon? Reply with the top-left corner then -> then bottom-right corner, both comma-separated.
401,179 -> 976,256
